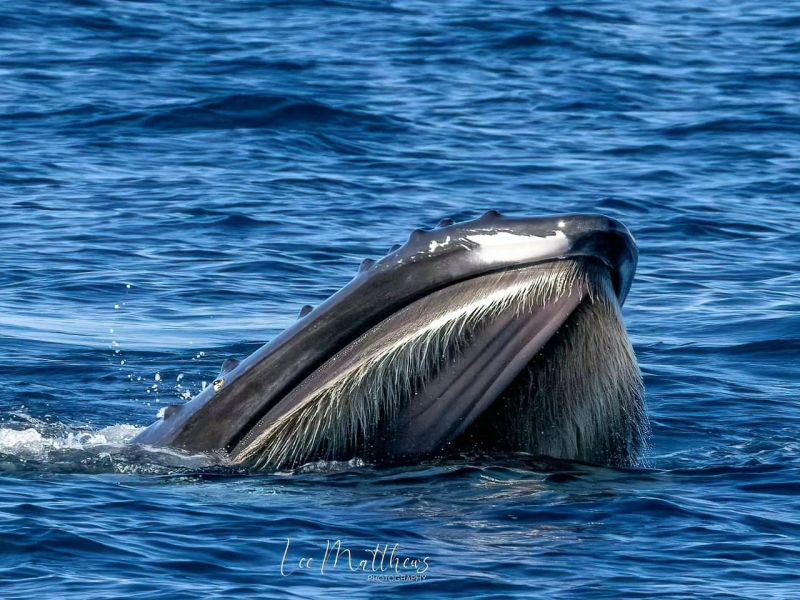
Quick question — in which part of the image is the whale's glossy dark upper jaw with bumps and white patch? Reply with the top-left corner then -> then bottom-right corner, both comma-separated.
137,211 -> 637,460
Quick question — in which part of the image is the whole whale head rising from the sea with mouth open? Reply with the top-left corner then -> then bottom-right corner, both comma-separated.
134,211 -> 649,470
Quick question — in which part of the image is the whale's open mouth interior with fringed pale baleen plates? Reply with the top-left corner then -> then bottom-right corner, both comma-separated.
230,258 -> 647,468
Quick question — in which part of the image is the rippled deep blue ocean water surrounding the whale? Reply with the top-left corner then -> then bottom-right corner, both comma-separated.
0,0 -> 800,600
